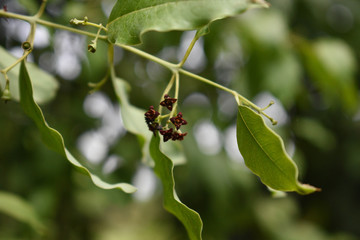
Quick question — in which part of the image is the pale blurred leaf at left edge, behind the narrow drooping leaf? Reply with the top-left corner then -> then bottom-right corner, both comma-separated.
0,46 -> 59,104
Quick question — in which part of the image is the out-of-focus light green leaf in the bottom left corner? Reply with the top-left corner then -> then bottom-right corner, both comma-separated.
0,191 -> 45,233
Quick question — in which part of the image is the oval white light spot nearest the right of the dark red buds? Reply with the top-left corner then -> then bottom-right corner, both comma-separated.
194,120 -> 222,155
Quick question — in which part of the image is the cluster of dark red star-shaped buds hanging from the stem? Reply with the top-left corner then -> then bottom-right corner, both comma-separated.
145,94 -> 187,142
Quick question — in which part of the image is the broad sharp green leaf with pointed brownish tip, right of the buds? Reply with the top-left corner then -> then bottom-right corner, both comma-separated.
237,106 -> 319,194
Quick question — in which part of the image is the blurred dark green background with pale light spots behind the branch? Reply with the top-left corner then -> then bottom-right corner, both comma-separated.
0,0 -> 360,240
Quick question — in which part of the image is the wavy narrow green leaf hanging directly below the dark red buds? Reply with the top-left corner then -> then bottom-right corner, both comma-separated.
150,135 -> 202,240
